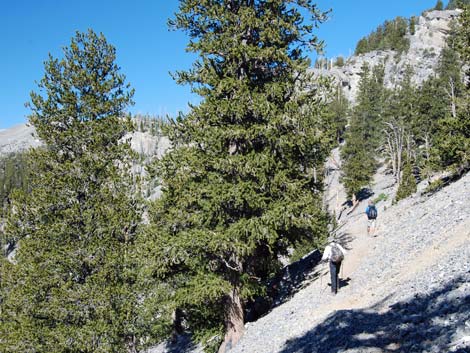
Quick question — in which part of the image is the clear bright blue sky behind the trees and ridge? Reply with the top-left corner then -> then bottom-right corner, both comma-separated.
0,0 -> 447,129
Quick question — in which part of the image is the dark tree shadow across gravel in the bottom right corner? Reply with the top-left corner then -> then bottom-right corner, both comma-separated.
281,273 -> 470,353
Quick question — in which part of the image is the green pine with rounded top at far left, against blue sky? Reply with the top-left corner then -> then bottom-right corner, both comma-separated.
0,30 -> 141,353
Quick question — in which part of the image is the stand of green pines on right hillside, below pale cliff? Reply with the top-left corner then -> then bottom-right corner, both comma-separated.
342,4 -> 470,201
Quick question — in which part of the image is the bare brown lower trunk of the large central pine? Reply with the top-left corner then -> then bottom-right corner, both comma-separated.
218,287 -> 245,353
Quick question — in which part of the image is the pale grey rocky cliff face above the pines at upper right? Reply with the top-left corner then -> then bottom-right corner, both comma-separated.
312,10 -> 460,102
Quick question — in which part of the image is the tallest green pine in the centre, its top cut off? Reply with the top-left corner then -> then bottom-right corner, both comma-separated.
145,0 -> 334,351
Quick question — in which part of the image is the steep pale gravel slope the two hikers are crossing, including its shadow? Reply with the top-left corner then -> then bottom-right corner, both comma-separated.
230,164 -> 470,353
